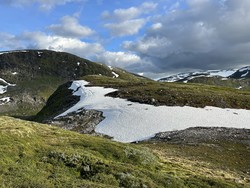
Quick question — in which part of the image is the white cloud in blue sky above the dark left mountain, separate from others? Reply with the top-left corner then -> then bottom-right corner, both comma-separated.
49,16 -> 94,38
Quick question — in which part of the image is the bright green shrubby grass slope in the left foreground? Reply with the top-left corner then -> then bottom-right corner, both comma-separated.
0,116 -> 241,188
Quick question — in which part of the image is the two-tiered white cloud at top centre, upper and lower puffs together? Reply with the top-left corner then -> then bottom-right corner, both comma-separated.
102,2 -> 157,37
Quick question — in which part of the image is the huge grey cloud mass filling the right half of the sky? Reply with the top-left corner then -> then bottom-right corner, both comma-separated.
123,0 -> 250,73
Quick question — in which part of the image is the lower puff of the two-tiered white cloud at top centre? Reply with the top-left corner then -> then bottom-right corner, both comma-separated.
104,19 -> 146,37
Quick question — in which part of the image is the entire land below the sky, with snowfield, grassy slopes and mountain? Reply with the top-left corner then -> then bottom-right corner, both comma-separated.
0,50 -> 250,187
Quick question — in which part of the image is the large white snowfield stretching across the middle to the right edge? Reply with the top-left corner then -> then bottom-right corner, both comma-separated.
59,80 -> 250,142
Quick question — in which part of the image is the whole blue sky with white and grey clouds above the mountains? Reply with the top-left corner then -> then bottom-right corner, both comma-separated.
0,0 -> 250,78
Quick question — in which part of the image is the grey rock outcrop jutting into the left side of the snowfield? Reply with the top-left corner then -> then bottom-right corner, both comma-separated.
45,109 -> 104,134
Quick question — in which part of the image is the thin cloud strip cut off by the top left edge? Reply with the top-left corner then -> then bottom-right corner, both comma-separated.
0,0 -> 86,10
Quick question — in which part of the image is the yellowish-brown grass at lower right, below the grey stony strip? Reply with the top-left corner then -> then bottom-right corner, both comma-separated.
141,141 -> 250,187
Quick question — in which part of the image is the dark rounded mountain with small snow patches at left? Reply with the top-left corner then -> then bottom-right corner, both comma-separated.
0,50 -> 144,116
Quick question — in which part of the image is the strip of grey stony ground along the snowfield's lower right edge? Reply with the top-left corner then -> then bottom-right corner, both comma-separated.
151,127 -> 250,145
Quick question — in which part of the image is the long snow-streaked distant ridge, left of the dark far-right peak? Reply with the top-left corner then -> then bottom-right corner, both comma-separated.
158,69 -> 236,83
